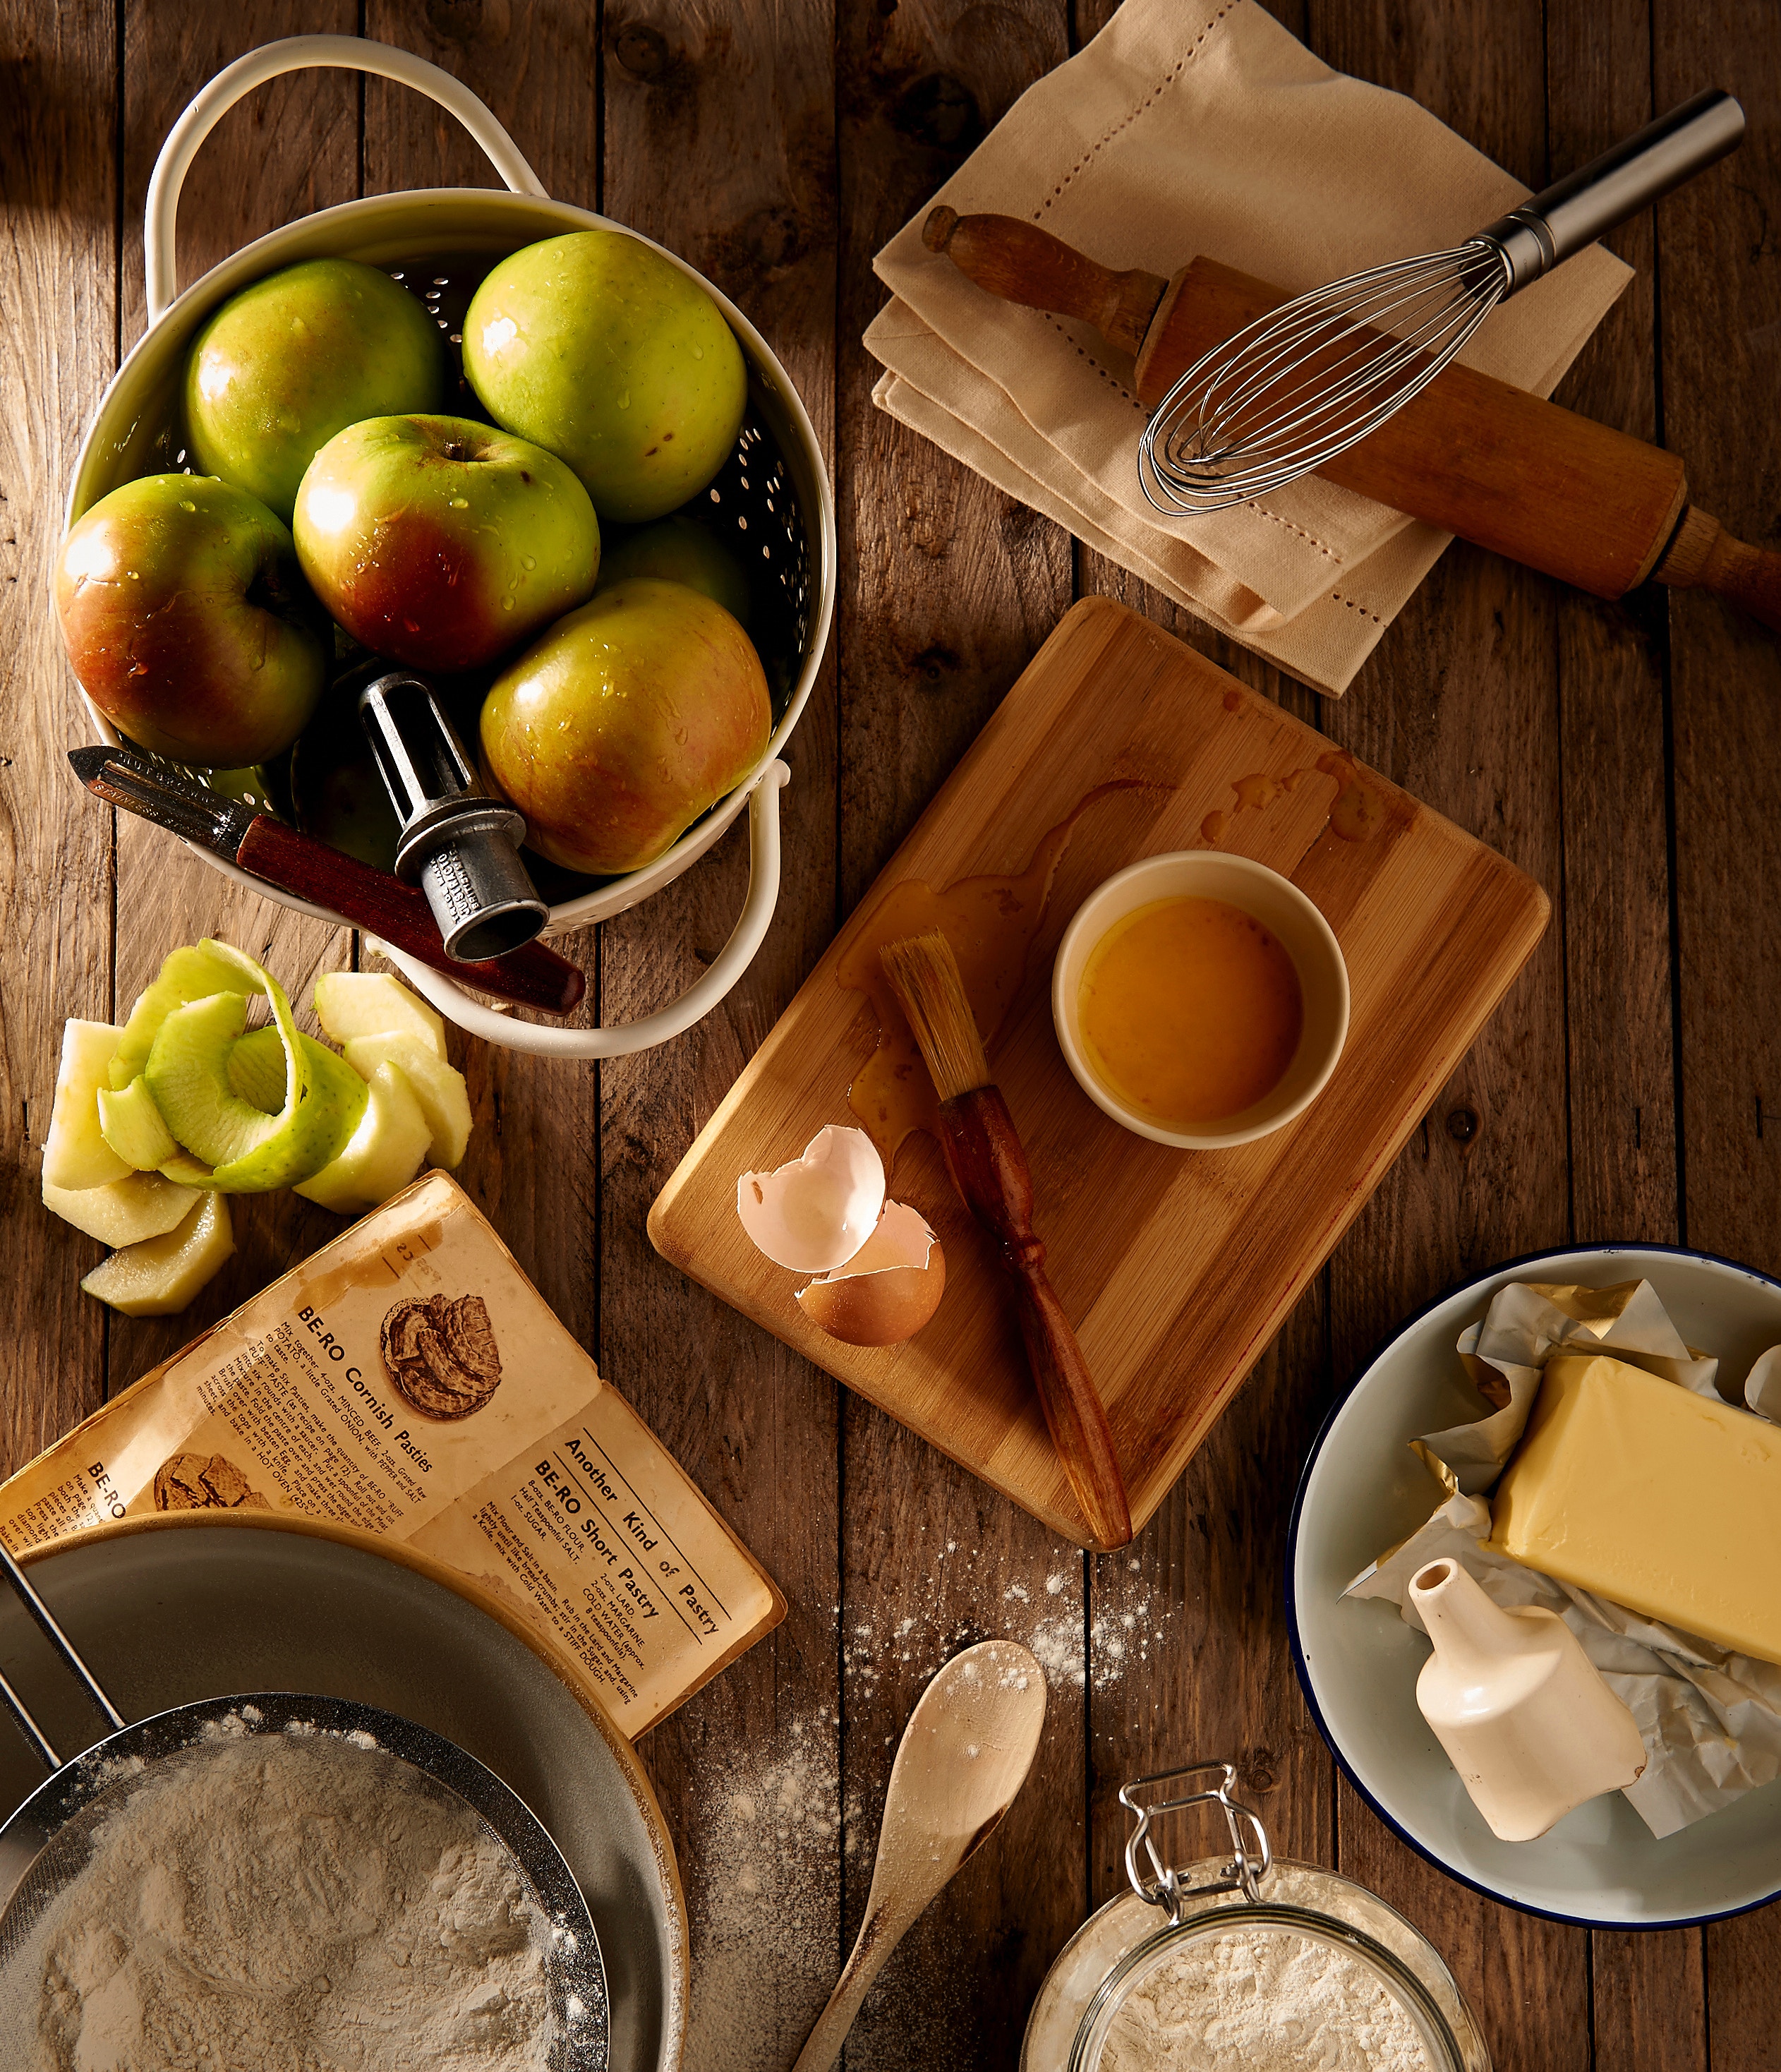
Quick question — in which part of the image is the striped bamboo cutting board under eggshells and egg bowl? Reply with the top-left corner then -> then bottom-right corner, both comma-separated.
648,599 -> 1547,1543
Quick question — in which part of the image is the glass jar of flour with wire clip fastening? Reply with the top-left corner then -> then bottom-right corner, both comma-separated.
1021,1761 -> 1491,2072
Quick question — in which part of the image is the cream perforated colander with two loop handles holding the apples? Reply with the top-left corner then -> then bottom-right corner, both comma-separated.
66,35 -> 837,1056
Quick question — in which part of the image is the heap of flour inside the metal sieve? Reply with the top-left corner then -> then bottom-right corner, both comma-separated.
0,1732 -> 555,2072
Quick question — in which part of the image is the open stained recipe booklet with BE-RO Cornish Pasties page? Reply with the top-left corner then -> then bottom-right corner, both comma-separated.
0,1173 -> 785,1736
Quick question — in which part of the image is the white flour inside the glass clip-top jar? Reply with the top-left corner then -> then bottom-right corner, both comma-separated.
1099,1929 -> 1433,2072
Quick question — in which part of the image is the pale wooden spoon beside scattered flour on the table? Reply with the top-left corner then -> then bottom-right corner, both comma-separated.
791,1641 -> 1046,2072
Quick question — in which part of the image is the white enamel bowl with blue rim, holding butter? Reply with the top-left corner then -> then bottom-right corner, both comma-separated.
1286,1246 -> 1781,1929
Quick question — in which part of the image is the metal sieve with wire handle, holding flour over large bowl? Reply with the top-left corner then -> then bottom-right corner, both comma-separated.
0,1546 -> 609,2072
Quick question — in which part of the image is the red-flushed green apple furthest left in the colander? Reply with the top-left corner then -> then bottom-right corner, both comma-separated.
56,474 -> 332,769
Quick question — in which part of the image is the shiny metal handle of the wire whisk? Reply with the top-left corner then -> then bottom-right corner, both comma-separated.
1475,87 -> 1744,294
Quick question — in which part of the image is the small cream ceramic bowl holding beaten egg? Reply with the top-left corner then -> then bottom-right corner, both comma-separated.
1052,850 -> 1348,1152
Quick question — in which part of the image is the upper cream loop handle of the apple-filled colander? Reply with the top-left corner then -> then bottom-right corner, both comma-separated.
143,35 -> 545,323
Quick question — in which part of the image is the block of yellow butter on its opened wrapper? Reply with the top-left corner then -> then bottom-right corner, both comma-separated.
1489,1355 -> 1781,1662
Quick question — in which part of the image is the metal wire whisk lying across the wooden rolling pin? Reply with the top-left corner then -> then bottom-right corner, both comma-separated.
1137,89 -> 1744,516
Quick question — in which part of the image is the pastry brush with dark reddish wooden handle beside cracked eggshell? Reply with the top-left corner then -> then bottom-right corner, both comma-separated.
878,932 -> 1130,1550
